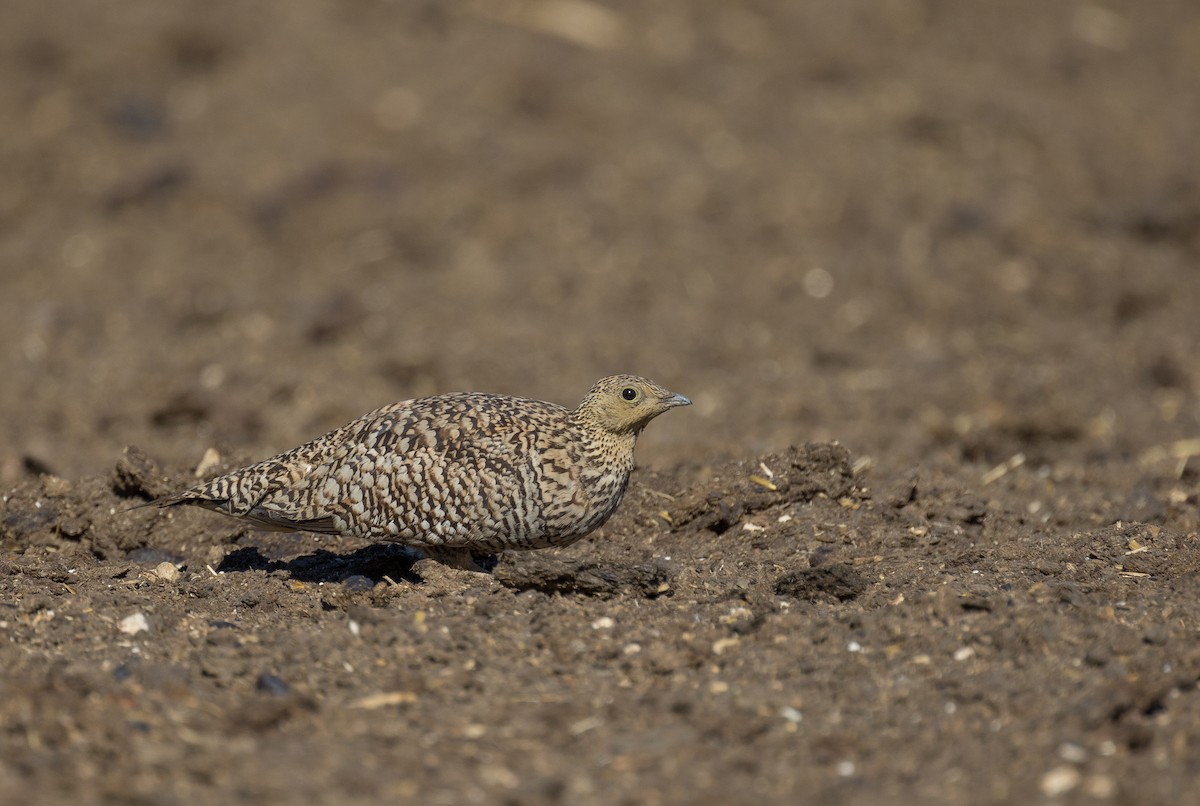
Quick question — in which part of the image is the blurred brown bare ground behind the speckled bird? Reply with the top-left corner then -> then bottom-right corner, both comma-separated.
0,0 -> 1200,483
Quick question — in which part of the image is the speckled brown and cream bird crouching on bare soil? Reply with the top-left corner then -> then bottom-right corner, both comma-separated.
148,375 -> 691,571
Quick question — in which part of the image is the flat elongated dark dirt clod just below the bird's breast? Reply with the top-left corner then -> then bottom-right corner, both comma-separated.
493,555 -> 671,599
